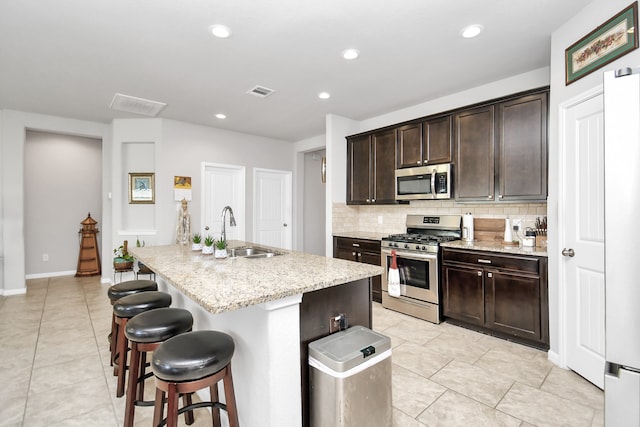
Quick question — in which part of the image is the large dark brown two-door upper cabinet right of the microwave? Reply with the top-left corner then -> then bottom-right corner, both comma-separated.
454,91 -> 547,202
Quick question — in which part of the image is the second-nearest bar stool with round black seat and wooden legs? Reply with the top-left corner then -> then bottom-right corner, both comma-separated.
124,307 -> 193,427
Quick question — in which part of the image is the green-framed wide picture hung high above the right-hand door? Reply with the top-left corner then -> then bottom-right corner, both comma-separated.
565,2 -> 638,85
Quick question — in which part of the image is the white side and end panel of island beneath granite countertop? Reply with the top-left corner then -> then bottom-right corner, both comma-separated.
158,278 -> 302,427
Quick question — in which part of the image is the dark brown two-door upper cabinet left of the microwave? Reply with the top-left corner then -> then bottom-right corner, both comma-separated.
347,129 -> 396,205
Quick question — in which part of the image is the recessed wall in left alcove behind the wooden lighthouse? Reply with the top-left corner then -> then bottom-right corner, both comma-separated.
24,131 -> 101,277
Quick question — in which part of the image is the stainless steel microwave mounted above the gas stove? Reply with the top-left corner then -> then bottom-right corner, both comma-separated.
396,163 -> 453,200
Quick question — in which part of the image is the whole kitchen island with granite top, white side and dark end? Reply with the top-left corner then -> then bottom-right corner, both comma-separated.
130,241 -> 382,426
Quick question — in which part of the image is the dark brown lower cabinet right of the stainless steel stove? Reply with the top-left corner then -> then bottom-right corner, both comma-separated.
442,248 -> 549,349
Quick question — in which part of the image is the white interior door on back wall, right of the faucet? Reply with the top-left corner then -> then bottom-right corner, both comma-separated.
253,169 -> 292,249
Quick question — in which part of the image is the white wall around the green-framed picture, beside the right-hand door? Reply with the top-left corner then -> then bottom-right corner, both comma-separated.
547,0 -> 640,359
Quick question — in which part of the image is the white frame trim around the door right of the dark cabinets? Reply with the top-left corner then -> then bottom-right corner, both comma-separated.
549,84 -> 604,369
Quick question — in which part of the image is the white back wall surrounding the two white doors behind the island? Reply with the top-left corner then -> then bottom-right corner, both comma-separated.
113,119 -> 297,262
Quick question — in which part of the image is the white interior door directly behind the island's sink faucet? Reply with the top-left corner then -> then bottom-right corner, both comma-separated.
202,162 -> 246,244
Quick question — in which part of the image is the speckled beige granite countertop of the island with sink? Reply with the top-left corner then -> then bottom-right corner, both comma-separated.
129,241 -> 383,314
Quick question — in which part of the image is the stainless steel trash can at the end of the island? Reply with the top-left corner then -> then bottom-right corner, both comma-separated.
309,326 -> 391,427
